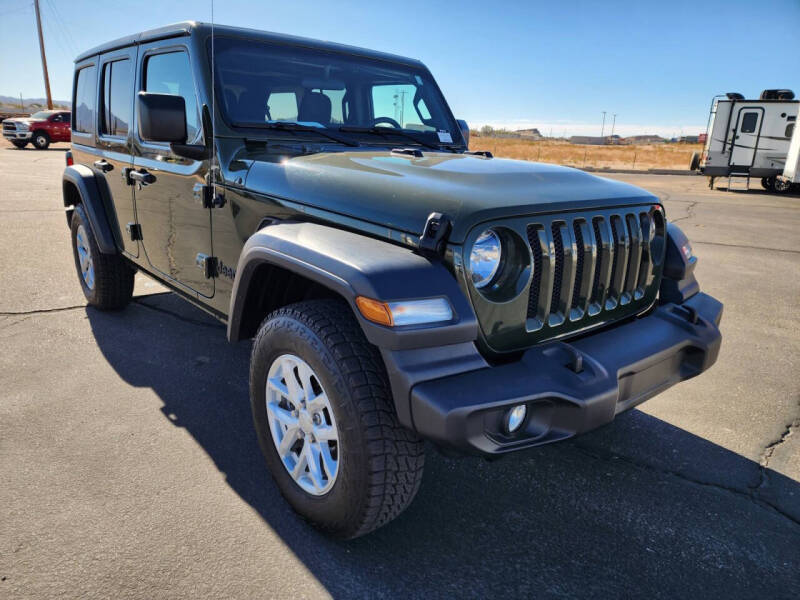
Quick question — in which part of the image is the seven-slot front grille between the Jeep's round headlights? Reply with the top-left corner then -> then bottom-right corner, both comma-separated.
526,206 -> 664,337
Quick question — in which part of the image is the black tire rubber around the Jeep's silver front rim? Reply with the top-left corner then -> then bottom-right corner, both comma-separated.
250,300 -> 425,539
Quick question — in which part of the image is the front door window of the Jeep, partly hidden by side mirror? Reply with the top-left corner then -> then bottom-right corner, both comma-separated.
144,51 -> 200,142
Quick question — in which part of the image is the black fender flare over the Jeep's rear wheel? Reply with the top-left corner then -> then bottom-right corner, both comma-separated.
61,165 -> 122,254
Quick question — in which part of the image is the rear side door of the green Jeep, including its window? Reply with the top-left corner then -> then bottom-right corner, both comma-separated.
97,48 -> 139,257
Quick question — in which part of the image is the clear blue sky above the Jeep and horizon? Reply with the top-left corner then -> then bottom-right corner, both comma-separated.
0,0 -> 800,135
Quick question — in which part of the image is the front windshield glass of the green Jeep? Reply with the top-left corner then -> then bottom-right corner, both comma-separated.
209,37 -> 463,147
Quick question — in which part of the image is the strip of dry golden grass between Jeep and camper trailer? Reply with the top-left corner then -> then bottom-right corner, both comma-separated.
469,134 -> 702,170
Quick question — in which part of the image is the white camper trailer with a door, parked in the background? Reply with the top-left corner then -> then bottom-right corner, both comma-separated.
692,90 -> 800,191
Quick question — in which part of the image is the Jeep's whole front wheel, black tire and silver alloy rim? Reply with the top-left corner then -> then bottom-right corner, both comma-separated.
250,300 -> 425,538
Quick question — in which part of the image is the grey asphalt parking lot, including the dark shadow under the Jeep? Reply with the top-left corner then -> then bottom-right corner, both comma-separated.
0,142 -> 800,598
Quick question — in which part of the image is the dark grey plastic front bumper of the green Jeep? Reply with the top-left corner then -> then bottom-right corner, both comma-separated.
410,293 -> 722,455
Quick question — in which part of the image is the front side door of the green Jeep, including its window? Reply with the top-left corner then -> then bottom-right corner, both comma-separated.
133,42 -> 214,297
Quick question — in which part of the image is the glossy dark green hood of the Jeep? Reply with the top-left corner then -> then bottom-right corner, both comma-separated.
240,150 -> 657,243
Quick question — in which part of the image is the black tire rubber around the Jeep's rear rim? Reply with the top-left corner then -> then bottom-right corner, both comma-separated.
70,205 -> 136,310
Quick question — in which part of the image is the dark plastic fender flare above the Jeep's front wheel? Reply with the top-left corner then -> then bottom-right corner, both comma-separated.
228,222 -> 478,350
